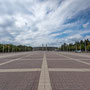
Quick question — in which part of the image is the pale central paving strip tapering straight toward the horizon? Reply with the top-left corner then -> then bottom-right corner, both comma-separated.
38,52 -> 52,90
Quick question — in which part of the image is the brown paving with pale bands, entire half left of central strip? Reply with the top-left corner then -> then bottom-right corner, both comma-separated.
0,52 -> 43,90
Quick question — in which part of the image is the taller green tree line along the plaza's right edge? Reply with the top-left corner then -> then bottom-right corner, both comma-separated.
59,39 -> 90,51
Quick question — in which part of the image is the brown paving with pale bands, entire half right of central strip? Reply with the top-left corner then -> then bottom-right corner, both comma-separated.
46,52 -> 90,90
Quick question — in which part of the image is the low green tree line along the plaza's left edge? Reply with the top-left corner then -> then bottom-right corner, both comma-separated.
0,44 -> 32,52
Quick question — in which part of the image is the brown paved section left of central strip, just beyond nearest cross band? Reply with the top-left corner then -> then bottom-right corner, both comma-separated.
0,60 -> 42,69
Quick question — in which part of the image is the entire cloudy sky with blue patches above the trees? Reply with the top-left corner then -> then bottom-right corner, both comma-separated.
0,0 -> 90,46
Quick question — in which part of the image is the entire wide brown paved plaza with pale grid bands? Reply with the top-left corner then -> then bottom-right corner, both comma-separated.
0,51 -> 90,90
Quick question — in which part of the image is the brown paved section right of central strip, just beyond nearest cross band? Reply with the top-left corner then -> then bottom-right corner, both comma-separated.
47,60 -> 90,68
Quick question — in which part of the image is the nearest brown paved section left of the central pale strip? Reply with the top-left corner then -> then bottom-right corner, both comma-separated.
0,71 -> 40,90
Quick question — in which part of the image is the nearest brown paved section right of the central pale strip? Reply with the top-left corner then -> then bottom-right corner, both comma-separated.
49,72 -> 90,90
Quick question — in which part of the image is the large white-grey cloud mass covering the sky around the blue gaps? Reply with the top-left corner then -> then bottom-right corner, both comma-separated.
0,0 -> 90,46
